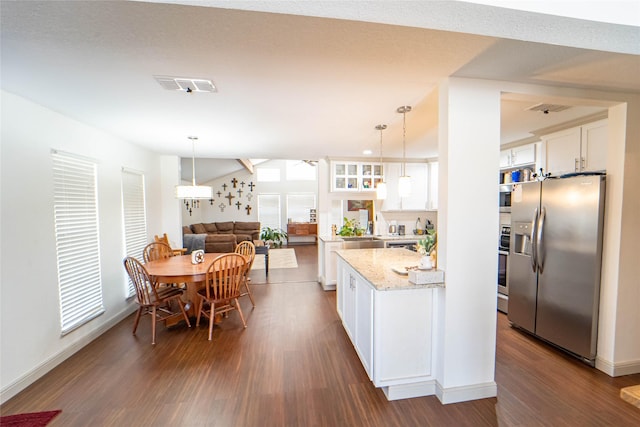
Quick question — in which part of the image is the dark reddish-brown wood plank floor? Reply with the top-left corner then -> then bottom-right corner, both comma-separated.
0,245 -> 640,427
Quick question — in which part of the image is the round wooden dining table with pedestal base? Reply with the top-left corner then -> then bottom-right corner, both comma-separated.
144,252 -> 225,326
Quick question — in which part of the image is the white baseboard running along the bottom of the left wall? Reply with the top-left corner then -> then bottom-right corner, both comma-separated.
0,304 -> 138,403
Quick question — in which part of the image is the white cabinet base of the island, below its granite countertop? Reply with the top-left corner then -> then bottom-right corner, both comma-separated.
336,257 -> 435,394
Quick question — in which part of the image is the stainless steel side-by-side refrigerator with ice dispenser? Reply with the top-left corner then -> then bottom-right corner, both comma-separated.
508,175 -> 605,365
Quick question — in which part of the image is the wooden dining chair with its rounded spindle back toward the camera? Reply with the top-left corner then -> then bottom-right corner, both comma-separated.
196,253 -> 249,341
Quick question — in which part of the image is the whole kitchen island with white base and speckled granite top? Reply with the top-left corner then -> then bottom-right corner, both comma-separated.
336,249 -> 444,400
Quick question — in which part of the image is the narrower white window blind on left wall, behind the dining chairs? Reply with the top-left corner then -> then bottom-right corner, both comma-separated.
122,169 -> 147,297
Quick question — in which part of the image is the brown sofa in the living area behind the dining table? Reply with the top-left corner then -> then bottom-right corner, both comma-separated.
182,221 -> 260,252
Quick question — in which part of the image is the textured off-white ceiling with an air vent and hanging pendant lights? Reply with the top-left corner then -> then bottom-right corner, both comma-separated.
1,1 -> 640,181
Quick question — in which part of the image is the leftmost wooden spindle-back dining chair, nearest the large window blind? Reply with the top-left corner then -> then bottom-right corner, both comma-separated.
124,257 -> 191,344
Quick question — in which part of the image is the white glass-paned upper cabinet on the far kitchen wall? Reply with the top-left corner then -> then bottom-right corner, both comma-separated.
331,161 -> 383,191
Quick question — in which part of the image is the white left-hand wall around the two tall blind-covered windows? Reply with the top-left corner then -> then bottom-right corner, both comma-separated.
0,91 -> 168,401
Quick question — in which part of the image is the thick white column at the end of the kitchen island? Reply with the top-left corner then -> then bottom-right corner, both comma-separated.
435,78 -> 500,403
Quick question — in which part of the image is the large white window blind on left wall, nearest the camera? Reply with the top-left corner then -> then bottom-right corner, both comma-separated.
51,152 -> 104,335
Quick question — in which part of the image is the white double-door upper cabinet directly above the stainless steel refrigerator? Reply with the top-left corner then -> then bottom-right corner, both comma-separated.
542,119 -> 607,175
